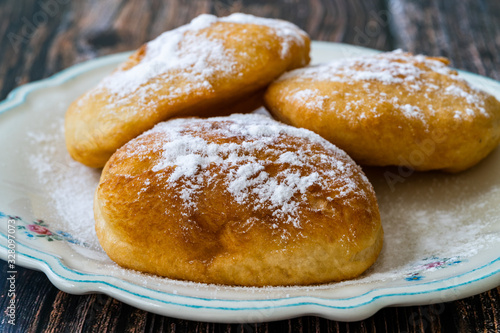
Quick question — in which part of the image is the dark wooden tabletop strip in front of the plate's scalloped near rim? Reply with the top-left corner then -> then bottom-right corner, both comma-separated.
0,261 -> 500,333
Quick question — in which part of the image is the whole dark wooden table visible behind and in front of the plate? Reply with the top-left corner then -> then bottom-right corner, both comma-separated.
0,0 -> 500,332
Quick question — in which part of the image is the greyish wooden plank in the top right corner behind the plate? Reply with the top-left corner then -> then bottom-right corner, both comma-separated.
389,0 -> 500,80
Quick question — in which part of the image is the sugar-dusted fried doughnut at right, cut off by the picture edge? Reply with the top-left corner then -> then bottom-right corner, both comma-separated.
265,51 -> 500,172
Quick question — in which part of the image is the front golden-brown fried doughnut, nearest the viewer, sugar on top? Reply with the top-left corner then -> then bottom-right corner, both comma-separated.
94,114 -> 383,286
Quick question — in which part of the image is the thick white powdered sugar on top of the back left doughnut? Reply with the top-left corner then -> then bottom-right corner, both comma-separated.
97,13 -> 305,100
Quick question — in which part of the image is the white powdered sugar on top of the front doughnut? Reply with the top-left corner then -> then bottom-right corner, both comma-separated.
125,114 -> 366,228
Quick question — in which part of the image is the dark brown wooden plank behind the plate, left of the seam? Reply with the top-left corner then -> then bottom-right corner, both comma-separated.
0,0 -> 391,100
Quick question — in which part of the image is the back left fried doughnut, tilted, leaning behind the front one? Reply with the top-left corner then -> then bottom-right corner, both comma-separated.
65,13 -> 310,167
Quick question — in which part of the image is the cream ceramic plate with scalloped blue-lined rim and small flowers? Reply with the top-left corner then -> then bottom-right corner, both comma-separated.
0,42 -> 500,322
